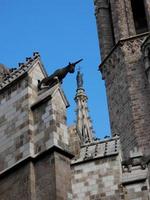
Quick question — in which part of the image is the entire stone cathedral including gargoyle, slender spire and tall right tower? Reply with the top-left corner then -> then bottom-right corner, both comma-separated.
0,0 -> 150,200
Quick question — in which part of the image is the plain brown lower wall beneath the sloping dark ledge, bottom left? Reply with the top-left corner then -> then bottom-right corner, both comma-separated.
0,152 -> 72,200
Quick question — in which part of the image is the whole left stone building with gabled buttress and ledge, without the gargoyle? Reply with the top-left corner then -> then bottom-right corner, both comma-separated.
0,53 -> 72,200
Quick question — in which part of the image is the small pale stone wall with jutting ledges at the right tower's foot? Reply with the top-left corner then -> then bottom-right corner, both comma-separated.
122,148 -> 150,200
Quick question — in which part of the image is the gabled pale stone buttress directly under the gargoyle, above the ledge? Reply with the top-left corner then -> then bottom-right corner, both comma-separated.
32,85 -> 69,154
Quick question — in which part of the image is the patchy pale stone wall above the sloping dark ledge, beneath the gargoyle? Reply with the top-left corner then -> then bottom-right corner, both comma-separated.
0,56 -> 69,171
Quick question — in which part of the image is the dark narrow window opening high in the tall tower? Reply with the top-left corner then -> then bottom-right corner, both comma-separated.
131,0 -> 148,34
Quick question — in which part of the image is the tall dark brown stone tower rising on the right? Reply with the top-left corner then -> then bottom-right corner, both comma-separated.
94,0 -> 150,157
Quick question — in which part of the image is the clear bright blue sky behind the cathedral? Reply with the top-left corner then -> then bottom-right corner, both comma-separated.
0,0 -> 110,138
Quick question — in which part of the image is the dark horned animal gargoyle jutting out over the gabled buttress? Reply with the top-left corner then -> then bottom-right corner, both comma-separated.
38,59 -> 83,90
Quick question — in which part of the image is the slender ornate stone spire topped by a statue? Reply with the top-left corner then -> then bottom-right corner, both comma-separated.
75,71 -> 94,144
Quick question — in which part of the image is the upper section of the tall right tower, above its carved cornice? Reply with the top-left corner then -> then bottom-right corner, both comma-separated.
94,0 -> 150,59
